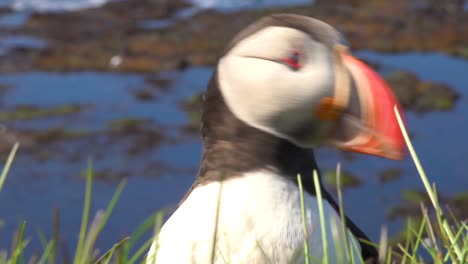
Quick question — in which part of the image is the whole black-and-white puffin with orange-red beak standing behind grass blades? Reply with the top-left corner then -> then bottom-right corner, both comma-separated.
147,13 -> 404,264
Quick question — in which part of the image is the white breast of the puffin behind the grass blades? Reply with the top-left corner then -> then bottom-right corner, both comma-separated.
147,171 -> 360,264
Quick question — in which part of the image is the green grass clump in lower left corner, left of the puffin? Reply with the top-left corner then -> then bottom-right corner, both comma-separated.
0,144 -> 157,264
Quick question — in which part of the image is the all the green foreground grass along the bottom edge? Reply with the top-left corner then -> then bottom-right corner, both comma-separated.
0,105 -> 468,264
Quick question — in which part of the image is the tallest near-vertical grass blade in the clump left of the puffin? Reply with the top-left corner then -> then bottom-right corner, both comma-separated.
73,161 -> 93,264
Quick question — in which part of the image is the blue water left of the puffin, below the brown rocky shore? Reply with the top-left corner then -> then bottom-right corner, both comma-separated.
0,68 -> 208,255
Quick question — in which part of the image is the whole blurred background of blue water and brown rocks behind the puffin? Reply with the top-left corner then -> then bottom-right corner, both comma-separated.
0,0 -> 468,258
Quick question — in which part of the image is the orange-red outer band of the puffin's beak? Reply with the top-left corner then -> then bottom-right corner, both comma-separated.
341,53 -> 405,159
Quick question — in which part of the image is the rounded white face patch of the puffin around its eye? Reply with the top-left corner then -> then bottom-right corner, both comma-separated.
218,26 -> 334,145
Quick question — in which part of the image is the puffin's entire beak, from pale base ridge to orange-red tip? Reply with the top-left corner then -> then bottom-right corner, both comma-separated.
326,45 -> 404,159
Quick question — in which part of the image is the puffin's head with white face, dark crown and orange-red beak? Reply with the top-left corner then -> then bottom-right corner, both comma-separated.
217,14 -> 404,158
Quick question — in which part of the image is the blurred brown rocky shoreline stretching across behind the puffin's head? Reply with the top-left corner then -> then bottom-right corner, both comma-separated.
0,0 -> 468,72
